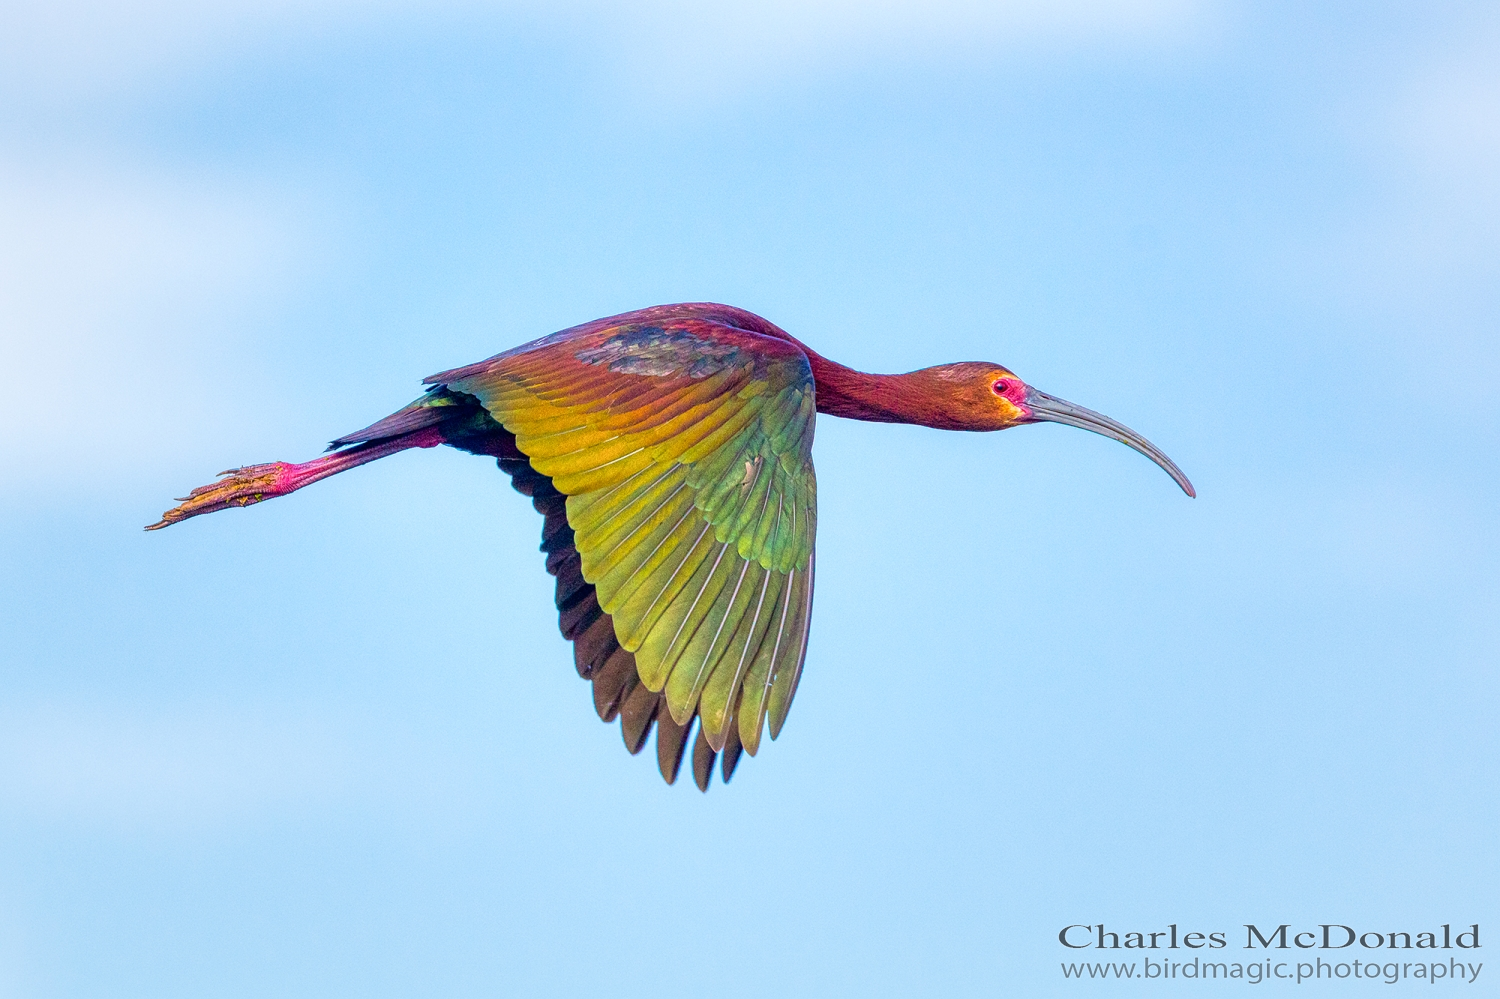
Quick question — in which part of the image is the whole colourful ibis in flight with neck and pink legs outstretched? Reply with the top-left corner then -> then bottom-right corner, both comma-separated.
146,303 -> 1196,791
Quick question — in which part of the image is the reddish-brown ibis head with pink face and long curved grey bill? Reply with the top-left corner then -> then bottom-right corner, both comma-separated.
914,362 -> 1197,497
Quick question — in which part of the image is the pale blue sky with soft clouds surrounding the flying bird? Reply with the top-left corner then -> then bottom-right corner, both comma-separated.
0,0 -> 1500,998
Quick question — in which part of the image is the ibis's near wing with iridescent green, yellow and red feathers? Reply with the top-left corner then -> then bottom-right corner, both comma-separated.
438,321 -> 818,756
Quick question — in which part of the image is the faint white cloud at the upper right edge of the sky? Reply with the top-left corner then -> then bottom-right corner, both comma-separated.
1293,18 -> 1500,354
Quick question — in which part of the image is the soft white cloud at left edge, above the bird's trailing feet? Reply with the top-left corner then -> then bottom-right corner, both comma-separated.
0,156 -> 305,488
